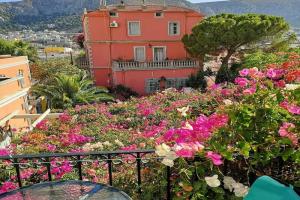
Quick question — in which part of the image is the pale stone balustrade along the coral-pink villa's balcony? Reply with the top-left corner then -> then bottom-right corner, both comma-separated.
113,60 -> 199,71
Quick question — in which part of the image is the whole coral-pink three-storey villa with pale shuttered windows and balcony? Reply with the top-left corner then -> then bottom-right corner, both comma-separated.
83,3 -> 204,95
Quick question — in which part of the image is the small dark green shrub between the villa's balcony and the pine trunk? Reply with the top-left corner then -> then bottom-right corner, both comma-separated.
187,69 -> 213,91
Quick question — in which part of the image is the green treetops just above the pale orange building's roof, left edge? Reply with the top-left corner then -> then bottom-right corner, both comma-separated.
0,39 -> 37,61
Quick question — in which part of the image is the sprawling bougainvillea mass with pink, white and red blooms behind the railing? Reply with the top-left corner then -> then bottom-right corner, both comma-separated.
0,50 -> 300,199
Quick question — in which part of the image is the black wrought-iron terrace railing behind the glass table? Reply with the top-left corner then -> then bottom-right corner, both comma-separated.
0,150 -> 171,200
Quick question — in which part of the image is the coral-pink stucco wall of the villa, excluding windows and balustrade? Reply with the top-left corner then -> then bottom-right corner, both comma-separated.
83,6 -> 203,94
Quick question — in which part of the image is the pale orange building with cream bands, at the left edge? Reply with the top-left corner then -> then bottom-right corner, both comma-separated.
0,56 -> 32,128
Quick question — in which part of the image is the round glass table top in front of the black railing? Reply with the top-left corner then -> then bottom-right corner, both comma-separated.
0,180 -> 131,200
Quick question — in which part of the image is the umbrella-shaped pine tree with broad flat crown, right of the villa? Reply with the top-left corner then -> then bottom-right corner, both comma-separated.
182,14 -> 289,81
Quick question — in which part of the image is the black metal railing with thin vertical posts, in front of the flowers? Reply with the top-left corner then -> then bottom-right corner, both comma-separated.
0,150 -> 171,200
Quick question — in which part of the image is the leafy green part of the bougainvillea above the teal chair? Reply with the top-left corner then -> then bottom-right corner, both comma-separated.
211,86 -> 300,183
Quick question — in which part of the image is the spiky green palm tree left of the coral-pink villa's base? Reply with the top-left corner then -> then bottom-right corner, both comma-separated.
32,73 -> 113,109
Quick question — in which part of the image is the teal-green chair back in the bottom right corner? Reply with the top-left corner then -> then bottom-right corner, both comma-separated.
244,176 -> 300,200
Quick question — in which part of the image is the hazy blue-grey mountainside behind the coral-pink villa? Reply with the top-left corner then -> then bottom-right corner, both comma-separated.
0,0 -> 300,32
